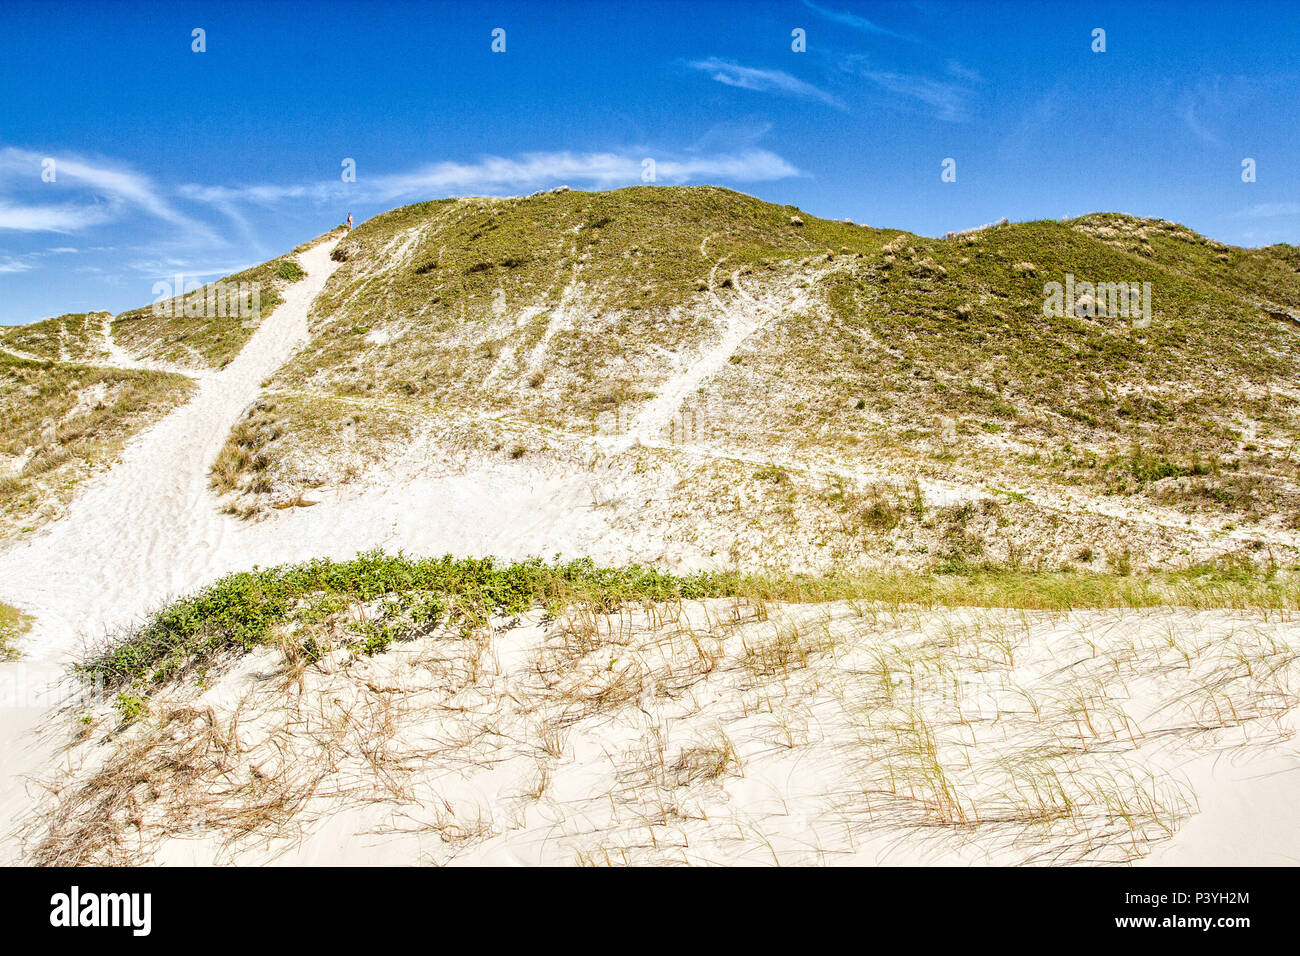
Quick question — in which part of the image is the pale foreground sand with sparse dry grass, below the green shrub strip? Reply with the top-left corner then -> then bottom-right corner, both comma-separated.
20,600 -> 1300,865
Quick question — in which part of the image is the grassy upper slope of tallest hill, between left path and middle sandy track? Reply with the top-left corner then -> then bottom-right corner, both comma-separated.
274,187 -> 888,427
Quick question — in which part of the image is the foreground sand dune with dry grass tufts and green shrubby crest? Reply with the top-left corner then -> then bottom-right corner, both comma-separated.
35,551 -> 1300,865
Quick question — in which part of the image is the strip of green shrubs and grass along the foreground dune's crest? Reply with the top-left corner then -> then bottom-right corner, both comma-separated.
81,550 -> 1300,692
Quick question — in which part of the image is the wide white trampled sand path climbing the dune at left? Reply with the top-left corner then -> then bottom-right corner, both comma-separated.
0,243 -> 338,659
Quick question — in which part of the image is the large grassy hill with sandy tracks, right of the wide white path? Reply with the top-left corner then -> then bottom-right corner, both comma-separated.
192,187 -> 1300,567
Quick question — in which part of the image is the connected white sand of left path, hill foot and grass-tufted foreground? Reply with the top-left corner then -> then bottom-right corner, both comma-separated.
0,243 -> 1300,865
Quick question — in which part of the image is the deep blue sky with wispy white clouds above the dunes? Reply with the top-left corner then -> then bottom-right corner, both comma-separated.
0,0 -> 1300,324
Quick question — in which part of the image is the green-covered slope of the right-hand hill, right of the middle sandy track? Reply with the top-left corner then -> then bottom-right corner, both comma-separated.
694,217 -> 1300,519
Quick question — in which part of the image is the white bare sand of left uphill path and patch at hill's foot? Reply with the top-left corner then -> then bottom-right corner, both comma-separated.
0,241 -> 610,860
